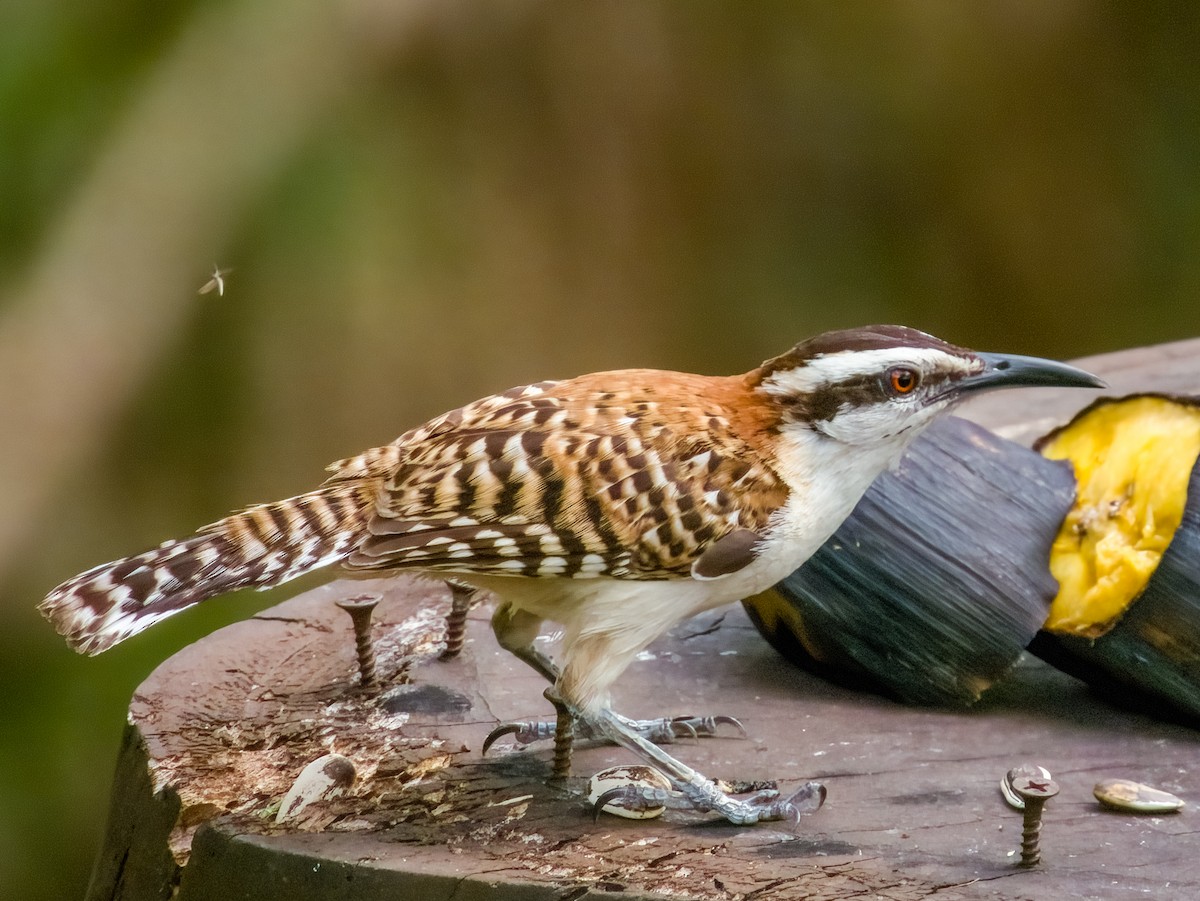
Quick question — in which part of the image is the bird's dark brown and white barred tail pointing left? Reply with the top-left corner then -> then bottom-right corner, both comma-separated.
38,482 -> 376,655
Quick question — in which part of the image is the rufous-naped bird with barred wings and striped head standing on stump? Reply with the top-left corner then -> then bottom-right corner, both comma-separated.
40,325 -> 1104,824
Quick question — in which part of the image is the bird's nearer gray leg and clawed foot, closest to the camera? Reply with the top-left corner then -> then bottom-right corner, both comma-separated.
583,704 -> 826,825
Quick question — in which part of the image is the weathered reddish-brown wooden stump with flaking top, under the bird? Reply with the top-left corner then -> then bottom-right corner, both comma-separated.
89,342 -> 1200,901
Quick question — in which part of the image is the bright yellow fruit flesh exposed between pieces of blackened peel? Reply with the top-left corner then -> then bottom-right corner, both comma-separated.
1042,397 -> 1200,638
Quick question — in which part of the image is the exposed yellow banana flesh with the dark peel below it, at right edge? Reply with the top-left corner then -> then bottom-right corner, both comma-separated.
1030,395 -> 1200,721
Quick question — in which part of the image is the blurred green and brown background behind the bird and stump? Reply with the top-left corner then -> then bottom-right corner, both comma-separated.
0,0 -> 1200,899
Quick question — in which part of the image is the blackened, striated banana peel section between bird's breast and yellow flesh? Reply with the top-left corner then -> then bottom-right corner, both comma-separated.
744,418 -> 1075,707
